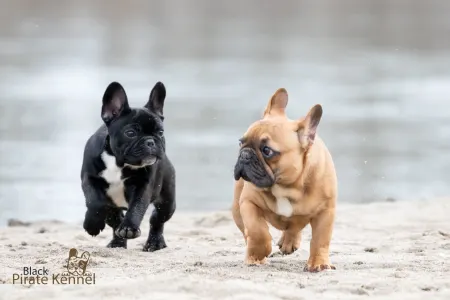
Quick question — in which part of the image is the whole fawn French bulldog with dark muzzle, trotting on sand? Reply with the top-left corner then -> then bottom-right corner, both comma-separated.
232,88 -> 337,272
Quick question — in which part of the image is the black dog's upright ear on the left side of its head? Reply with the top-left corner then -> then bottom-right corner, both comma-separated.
102,82 -> 130,124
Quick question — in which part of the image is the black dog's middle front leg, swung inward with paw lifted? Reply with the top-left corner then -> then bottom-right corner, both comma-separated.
115,188 -> 150,239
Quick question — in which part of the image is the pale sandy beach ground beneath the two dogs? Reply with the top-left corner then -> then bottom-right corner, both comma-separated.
0,199 -> 450,300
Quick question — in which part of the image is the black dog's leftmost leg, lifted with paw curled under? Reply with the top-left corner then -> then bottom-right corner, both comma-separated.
82,176 -> 107,236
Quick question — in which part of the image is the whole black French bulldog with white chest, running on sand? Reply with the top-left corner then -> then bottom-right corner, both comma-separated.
81,82 -> 176,252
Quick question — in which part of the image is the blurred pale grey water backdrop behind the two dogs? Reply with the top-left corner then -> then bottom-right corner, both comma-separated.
0,0 -> 450,225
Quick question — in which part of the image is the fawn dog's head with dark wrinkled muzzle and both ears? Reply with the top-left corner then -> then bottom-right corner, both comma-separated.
234,88 -> 322,188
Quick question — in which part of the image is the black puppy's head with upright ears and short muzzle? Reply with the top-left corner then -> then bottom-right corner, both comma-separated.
101,82 -> 166,168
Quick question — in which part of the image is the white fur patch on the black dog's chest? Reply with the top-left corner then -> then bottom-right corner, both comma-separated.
99,152 -> 128,208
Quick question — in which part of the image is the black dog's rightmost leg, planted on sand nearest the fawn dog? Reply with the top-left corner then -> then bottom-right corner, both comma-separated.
143,182 -> 176,252
